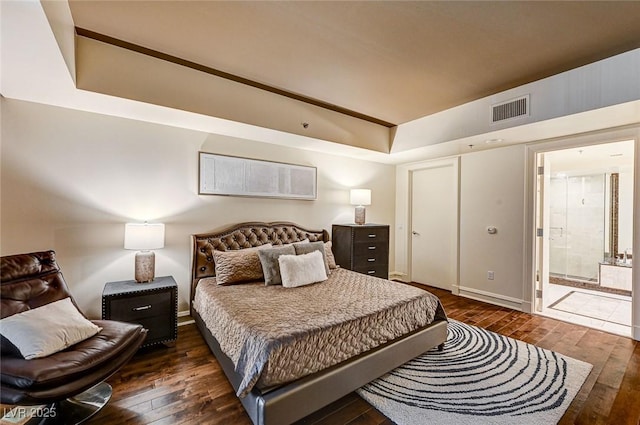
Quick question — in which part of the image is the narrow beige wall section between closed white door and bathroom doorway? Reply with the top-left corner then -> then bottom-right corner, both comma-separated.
460,145 -> 526,309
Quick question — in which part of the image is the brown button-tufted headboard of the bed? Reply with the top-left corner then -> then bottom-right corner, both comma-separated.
190,221 -> 329,308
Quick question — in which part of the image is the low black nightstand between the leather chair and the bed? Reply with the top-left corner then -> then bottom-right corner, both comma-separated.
102,276 -> 178,347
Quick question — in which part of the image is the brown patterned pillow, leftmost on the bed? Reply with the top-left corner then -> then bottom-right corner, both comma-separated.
213,243 -> 272,285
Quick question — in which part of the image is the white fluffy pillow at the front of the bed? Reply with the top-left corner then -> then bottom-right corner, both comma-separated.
278,251 -> 327,288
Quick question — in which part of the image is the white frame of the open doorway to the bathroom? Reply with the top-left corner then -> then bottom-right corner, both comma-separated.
522,125 -> 640,341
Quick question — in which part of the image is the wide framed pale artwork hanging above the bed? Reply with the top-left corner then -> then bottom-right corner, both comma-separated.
198,152 -> 318,200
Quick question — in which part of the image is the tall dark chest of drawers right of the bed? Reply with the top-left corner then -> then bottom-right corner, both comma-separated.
331,224 -> 389,279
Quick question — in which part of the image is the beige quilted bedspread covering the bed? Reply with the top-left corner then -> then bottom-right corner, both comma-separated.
194,269 -> 446,397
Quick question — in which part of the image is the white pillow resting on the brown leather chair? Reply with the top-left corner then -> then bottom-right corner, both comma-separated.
0,298 -> 102,359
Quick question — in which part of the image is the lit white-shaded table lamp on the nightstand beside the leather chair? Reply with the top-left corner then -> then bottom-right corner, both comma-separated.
124,222 -> 164,283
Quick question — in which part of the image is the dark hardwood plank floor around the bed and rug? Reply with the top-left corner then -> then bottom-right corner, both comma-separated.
28,288 -> 640,425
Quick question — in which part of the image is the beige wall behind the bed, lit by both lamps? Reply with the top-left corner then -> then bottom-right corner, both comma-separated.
0,98 -> 395,317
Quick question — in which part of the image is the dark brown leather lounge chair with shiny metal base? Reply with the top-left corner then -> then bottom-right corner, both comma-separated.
0,251 -> 147,424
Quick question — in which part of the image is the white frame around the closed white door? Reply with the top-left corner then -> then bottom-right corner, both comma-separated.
391,156 -> 460,295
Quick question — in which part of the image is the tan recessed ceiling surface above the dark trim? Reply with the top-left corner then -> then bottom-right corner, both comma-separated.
69,0 -> 640,126
